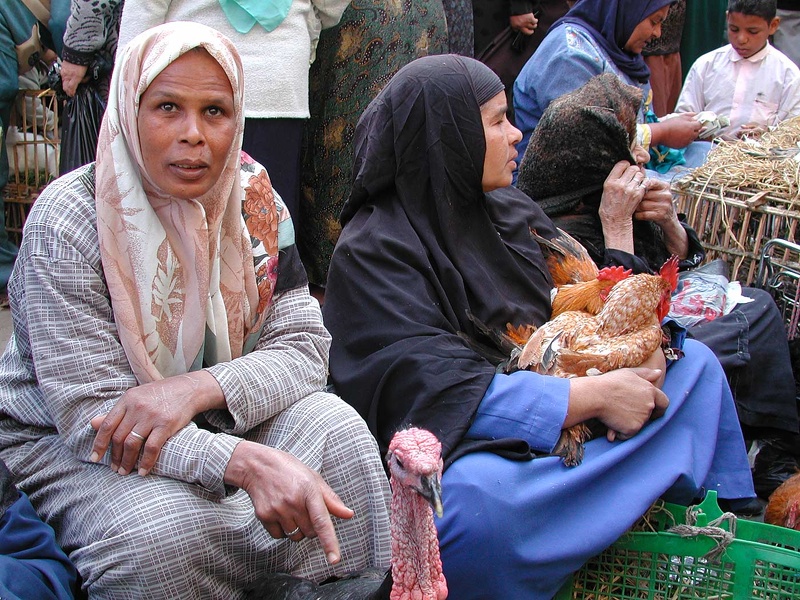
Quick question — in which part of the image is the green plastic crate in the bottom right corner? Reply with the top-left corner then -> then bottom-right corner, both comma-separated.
556,492 -> 800,600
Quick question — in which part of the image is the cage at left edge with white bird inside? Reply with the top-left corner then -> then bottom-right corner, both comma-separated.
3,89 -> 61,244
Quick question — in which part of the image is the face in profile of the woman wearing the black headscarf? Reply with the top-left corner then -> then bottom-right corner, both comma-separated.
481,92 -> 522,192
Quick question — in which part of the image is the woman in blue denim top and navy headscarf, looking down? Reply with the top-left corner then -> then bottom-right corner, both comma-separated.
514,0 -> 701,168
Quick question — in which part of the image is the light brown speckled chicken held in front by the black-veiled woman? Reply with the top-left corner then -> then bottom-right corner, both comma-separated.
517,256 -> 678,466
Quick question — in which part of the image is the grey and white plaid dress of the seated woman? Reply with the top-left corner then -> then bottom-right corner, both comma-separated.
0,168 -> 390,599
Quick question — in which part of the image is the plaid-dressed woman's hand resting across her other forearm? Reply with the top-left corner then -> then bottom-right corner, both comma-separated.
90,371 -> 225,476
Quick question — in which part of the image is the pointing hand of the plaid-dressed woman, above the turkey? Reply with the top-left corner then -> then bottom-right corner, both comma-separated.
224,441 -> 353,564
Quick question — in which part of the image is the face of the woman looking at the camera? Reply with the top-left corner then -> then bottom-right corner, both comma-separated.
137,50 -> 236,200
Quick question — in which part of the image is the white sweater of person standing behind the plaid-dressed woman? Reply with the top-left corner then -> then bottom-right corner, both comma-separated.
118,0 -> 350,119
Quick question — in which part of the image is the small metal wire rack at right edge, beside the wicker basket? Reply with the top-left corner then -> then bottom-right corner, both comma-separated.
755,238 -> 800,340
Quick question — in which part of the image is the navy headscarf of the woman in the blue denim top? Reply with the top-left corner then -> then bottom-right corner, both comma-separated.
553,0 -> 675,83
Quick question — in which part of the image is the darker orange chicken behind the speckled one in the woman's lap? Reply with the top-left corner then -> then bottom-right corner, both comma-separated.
532,229 -> 631,318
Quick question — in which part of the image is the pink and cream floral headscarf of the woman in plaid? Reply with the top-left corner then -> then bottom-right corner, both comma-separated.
96,22 -> 288,383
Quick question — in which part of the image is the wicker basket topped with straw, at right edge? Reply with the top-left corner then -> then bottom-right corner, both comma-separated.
673,181 -> 800,285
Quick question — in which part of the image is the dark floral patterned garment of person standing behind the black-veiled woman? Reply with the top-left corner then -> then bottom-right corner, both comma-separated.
297,0 -> 448,286
